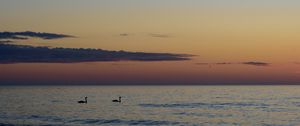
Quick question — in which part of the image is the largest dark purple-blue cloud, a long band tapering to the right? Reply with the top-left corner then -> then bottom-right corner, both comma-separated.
0,44 -> 192,63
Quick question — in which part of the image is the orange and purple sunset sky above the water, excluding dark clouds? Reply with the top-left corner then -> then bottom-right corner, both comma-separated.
0,0 -> 300,85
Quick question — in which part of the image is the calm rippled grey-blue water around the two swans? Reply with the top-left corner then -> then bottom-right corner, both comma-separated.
0,86 -> 300,126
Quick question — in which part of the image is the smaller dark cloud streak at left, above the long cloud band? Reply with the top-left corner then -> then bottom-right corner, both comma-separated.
0,31 -> 74,40
